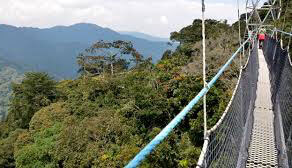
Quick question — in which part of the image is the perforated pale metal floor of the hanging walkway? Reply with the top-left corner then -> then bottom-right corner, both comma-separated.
246,50 -> 278,168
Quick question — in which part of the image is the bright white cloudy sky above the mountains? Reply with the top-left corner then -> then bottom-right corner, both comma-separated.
0,0 -> 264,37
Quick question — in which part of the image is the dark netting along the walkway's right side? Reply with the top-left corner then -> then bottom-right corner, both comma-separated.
263,38 -> 292,167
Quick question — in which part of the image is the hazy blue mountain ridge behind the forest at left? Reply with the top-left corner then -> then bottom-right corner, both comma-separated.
0,23 -> 175,78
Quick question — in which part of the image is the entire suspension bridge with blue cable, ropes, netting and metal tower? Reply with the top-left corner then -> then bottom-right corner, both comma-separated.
126,0 -> 292,168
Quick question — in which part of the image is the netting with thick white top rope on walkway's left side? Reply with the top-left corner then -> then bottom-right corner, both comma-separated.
198,45 -> 259,168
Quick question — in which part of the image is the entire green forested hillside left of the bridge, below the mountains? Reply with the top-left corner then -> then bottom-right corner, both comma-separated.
0,20 -> 239,168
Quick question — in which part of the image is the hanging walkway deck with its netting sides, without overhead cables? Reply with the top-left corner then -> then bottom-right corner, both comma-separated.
198,38 -> 292,168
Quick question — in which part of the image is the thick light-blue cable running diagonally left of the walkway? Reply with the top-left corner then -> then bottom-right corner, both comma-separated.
125,36 -> 251,168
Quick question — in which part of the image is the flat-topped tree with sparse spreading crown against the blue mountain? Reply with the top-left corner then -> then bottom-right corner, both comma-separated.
77,40 -> 143,76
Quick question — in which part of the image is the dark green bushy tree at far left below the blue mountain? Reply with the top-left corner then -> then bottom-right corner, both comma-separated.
8,73 -> 58,128
